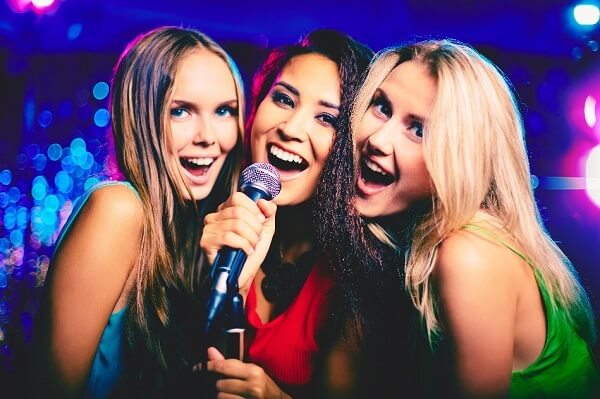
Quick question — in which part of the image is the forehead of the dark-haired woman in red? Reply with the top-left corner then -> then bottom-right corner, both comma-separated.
276,54 -> 341,104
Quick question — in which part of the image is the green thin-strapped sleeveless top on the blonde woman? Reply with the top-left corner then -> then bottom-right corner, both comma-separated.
463,224 -> 600,399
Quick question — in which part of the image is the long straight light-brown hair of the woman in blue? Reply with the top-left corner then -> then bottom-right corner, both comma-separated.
110,27 -> 244,376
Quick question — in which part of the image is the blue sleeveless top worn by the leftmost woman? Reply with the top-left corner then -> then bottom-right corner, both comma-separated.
56,181 -> 137,399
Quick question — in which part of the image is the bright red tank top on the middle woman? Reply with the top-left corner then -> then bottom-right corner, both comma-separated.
246,261 -> 333,393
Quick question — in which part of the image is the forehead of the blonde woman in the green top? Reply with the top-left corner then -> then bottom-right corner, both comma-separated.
380,60 -> 437,115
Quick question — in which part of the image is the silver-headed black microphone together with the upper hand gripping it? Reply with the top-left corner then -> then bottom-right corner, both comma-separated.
200,163 -> 281,329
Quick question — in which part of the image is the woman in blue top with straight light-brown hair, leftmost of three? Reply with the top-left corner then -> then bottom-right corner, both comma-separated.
31,27 -> 255,397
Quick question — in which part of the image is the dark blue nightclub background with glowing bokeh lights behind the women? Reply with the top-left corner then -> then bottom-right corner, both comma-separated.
0,0 -> 600,390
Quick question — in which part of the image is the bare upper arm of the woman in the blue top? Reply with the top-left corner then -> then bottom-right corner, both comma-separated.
34,186 -> 142,397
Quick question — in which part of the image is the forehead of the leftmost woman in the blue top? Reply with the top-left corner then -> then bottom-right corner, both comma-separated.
174,48 -> 235,93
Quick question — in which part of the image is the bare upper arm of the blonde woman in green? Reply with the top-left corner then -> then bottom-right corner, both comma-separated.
434,231 -> 518,398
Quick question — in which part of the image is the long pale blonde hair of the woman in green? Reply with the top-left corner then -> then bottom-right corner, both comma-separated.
352,40 -> 595,341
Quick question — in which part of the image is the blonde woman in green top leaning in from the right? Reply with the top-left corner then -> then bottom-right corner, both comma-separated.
336,40 -> 600,398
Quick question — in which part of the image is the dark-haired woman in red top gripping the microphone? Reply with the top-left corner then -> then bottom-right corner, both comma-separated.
201,30 -> 372,398
